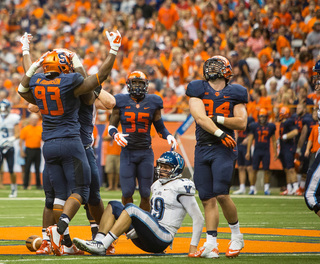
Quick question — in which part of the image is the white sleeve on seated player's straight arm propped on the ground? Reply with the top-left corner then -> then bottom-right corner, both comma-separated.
179,195 -> 204,246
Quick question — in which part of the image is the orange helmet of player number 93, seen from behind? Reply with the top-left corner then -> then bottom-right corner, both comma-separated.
42,51 -> 73,74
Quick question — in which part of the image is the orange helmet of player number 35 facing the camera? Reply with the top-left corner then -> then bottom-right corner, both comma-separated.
127,71 -> 149,98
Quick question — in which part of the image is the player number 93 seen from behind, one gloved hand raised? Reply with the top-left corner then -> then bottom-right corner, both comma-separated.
18,31 -> 121,255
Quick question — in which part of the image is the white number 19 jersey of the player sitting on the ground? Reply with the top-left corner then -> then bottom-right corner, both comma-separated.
151,178 -> 196,236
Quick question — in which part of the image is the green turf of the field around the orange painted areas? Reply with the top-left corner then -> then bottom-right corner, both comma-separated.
0,186 -> 320,264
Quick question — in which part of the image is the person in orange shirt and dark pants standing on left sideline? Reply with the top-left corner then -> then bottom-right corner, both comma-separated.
19,113 -> 42,190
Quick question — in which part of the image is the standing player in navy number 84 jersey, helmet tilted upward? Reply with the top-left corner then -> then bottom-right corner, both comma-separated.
186,56 -> 248,258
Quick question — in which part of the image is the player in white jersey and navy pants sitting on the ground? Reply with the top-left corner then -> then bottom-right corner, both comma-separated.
73,151 -> 203,256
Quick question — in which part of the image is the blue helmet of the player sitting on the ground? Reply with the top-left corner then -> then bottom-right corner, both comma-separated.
155,151 -> 184,184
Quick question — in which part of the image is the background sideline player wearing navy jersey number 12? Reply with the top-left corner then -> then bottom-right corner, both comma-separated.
246,108 -> 277,195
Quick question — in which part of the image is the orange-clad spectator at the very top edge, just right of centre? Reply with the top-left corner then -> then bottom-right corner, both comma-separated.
158,0 -> 179,30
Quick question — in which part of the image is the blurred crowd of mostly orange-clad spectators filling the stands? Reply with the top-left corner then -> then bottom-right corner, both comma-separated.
0,0 -> 320,194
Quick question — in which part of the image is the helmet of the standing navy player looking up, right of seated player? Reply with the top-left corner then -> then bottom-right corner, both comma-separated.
203,56 -> 233,83
